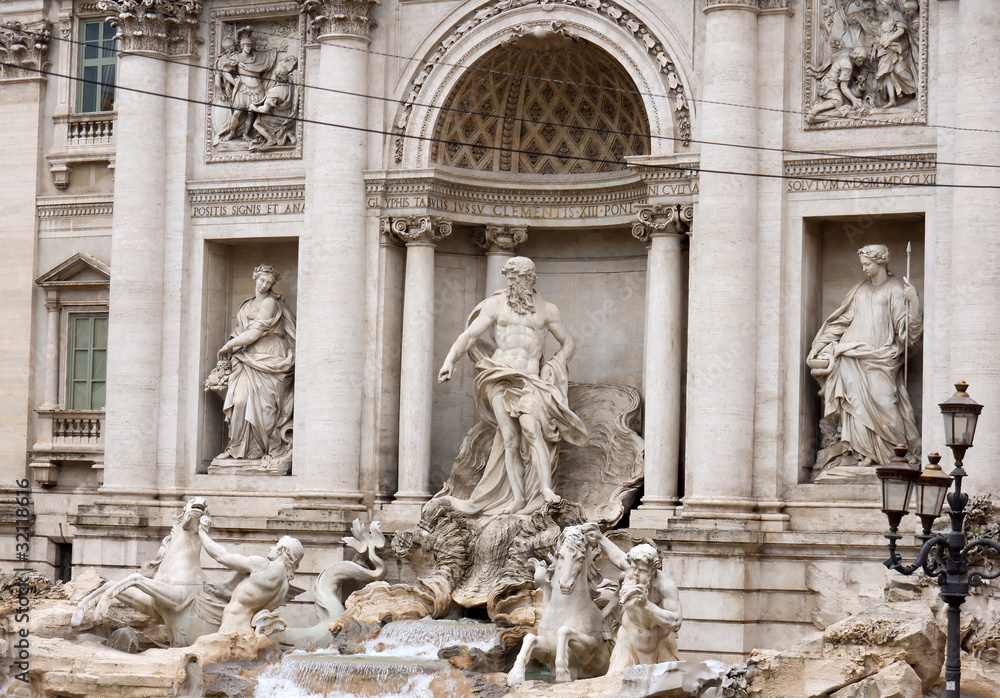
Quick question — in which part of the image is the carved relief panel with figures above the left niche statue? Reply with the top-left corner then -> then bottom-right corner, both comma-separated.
205,2 -> 305,162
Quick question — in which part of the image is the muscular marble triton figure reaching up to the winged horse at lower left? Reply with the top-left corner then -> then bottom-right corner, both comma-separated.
198,516 -> 304,633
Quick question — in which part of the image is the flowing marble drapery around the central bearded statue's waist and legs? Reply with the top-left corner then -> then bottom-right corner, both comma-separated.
438,301 -> 590,514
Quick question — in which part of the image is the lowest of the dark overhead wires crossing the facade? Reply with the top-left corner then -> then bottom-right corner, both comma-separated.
9,61 -> 1000,189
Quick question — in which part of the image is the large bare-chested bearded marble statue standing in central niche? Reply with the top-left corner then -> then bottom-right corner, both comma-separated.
438,257 -> 589,514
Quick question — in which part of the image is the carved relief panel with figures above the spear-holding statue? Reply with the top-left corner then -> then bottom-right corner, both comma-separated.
803,0 -> 928,129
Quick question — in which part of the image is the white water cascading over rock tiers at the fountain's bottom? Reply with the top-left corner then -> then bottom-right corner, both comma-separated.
254,618 -> 500,698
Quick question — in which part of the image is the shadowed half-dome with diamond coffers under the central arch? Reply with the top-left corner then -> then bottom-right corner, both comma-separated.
434,36 -> 649,175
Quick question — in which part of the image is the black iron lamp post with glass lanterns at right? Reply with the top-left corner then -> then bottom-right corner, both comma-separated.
875,382 -> 1000,698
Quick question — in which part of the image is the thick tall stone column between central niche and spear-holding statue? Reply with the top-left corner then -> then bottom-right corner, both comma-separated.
683,0 -> 758,519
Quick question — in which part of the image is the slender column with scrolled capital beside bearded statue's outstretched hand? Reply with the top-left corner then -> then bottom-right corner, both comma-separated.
386,216 -> 451,509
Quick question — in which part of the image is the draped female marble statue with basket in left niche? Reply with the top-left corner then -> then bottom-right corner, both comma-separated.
205,264 -> 295,474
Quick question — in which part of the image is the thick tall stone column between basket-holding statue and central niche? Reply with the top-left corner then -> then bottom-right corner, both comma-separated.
293,0 -> 377,518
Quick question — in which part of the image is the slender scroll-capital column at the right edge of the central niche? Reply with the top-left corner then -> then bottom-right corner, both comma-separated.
631,204 -> 694,529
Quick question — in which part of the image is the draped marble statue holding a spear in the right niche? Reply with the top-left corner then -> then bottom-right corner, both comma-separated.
806,245 -> 923,470
